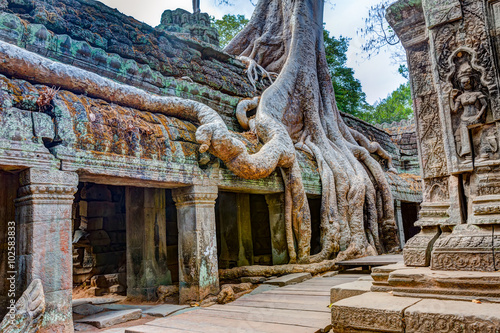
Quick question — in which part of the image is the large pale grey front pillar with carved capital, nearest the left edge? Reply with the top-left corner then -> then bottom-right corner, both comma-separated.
16,168 -> 78,332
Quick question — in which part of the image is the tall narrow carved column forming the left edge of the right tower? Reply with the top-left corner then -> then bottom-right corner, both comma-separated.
387,5 -> 450,266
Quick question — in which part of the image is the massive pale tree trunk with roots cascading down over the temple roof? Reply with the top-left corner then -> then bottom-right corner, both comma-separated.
225,0 -> 398,272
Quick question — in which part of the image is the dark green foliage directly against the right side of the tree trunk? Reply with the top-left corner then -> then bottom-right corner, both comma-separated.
323,30 -> 370,117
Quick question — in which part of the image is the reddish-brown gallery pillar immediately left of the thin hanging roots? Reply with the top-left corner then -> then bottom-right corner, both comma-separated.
266,193 -> 290,265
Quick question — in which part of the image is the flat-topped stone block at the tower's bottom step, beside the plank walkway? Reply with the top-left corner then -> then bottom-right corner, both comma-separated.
331,292 -> 420,333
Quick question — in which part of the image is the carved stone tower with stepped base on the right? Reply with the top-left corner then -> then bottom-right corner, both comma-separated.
332,0 -> 500,332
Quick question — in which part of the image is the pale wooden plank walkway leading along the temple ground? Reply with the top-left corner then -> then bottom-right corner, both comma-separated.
126,274 -> 366,333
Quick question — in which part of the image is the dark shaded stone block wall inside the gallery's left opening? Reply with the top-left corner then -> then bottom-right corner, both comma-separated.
73,183 -> 126,287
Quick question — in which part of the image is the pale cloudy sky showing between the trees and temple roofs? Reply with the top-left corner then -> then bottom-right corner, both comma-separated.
100,0 -> 405,104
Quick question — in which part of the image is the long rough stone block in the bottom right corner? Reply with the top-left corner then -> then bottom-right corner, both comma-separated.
405,299 -> 500,333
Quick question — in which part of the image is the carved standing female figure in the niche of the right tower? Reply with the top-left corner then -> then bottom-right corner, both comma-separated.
450,52 -> 488,162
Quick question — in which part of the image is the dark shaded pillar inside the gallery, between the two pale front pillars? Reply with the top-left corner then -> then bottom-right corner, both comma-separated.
125,187 -> 172,301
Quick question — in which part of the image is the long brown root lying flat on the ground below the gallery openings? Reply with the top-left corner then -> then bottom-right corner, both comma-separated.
219,259 -> 338,280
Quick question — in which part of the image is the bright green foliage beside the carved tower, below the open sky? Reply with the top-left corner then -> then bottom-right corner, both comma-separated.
362,82 -> 413,124
